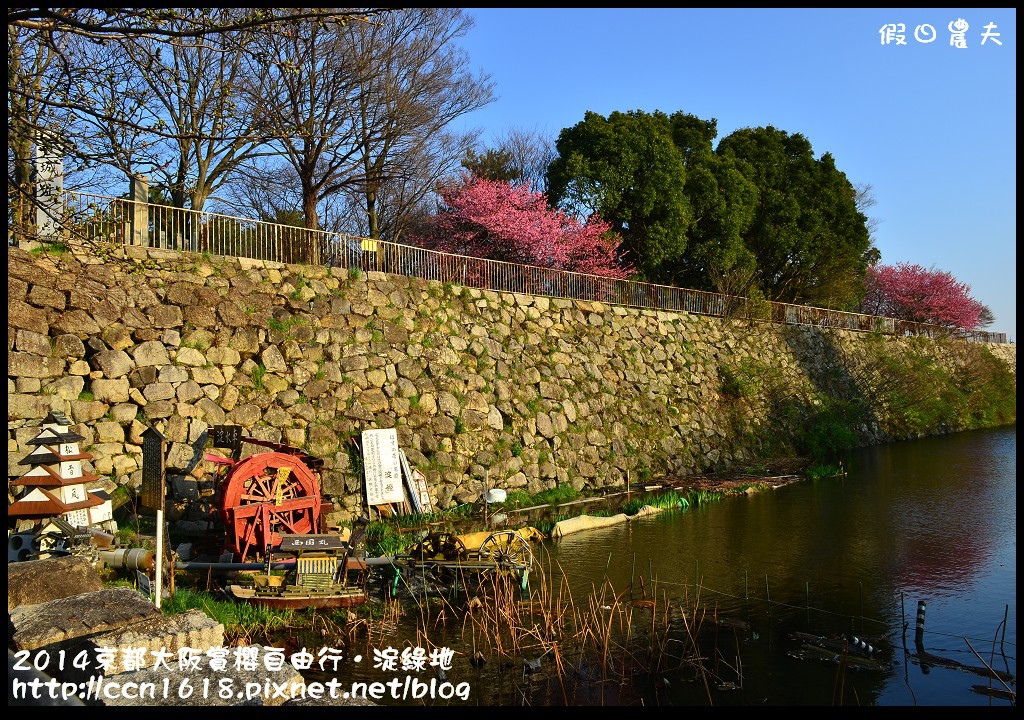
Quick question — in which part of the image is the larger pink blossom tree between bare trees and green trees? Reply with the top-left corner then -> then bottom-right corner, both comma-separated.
410,174 -> 633,280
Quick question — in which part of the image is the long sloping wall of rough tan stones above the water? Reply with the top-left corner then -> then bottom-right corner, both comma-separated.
7,248 -> 1016,519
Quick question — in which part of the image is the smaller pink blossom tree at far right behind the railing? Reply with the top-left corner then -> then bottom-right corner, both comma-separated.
861,262 -> 987,331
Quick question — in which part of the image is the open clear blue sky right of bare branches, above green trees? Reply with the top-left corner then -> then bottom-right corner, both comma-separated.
460,7 -> 1017,342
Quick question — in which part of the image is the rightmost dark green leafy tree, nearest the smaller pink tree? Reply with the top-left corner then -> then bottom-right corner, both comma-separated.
716,126 -> 879,309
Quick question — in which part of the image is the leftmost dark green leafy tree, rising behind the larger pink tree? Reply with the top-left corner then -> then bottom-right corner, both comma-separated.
547,111 -> 692,283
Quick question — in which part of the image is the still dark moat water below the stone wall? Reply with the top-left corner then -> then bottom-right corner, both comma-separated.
313,425 -> 1017,707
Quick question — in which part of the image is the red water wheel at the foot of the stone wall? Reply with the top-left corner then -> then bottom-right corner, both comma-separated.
220,453 -> 321,562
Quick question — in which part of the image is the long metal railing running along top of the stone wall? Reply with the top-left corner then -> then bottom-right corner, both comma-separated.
56,193 -> 1007,343
